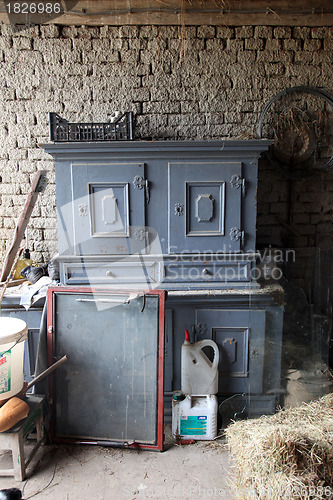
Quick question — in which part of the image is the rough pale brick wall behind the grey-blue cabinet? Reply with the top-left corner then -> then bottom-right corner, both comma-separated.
0,25 -> 333,282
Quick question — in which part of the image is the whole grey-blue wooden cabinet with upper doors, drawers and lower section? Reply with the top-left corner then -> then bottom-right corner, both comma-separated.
43,140 -> 283,420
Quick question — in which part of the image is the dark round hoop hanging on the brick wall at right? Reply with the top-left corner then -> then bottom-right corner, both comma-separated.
257,87 -> 333,180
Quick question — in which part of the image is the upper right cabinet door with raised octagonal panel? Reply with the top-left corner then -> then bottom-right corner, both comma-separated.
169,161 -> 243,253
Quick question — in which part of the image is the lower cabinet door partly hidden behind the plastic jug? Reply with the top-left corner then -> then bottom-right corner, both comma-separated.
196,309 -> 266,394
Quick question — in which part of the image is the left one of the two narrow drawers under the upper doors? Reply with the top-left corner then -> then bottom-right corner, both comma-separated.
60,259 -> 163,286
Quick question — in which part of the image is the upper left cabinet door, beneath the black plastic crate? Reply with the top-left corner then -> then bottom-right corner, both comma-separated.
71,163 -> 147,255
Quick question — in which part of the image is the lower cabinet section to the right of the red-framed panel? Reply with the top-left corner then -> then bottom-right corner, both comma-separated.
165,290 -> 283,418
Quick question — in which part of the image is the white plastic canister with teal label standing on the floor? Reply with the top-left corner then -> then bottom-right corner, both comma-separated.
172,392 -> 217,441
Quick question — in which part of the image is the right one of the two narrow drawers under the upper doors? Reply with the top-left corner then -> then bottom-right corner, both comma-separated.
163,260 -> 251,283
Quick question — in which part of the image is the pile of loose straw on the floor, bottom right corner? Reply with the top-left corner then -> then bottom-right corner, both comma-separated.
226,393 -> 333,500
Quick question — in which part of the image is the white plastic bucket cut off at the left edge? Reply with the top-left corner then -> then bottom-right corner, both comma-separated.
0,316 -> 28,400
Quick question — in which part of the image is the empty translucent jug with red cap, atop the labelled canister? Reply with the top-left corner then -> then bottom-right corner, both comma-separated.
181,330 -> 219,396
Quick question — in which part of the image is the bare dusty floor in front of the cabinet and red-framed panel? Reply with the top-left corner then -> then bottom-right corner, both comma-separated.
0,426 -> 234,500
